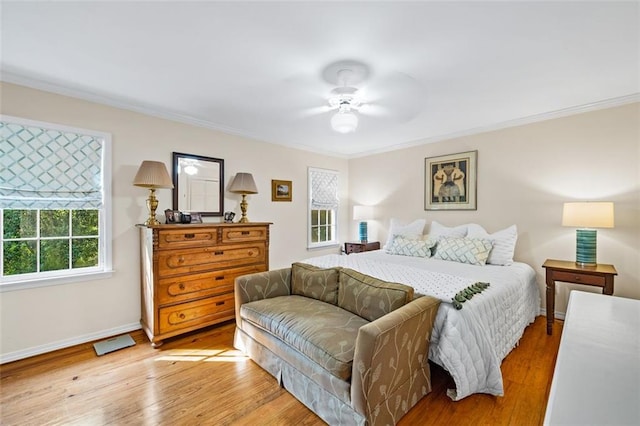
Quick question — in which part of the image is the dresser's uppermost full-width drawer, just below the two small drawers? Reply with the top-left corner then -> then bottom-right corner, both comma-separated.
158,242 -> 266,278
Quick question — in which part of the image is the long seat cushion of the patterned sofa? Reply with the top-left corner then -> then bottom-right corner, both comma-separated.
240,295 -> 368,380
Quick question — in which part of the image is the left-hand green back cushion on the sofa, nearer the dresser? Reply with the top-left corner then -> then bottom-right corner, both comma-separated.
291,262 -> 341,305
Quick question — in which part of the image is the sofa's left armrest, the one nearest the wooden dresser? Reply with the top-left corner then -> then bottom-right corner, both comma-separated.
234,268 -> 291,327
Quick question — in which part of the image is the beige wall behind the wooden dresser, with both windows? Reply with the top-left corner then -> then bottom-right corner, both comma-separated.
0,83 -> 348,361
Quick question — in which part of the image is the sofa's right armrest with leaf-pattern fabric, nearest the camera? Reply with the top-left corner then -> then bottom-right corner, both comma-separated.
351,296 -> 440,424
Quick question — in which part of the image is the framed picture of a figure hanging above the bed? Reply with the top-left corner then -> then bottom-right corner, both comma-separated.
424,151 -> 478,210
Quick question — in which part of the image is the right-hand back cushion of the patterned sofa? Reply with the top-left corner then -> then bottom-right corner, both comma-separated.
338,268 -> 413,321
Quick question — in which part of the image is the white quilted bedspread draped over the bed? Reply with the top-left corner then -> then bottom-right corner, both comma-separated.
302,250 -> 540,401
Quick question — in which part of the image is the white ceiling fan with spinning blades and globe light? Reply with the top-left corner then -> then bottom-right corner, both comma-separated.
312,60 -> 421,134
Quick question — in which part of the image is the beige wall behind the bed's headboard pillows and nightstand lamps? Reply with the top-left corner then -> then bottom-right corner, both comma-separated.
349,103 -> 640,314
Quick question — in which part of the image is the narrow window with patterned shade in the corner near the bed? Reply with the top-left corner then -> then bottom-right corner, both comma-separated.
308,167 -> 339,248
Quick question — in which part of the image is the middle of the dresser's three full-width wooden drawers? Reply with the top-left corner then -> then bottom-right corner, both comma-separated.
158,265 -> 265,305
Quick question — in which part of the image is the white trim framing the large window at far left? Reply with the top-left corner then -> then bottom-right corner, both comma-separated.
0,114 -> 113,293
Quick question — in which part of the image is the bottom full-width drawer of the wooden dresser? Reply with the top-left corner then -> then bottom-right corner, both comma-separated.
158,293 -> 235,333
